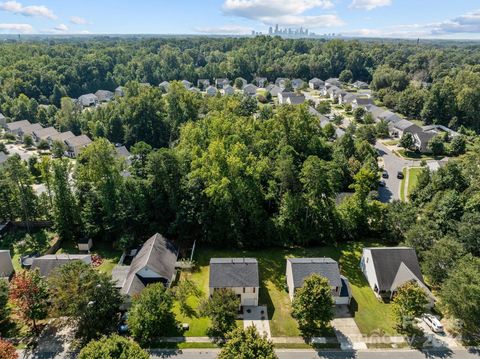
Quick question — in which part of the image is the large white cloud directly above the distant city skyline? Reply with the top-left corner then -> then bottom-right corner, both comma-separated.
222,0 -> 343,28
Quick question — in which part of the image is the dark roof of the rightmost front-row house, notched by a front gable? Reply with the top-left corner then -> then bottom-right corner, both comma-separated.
366,247 -> 423,291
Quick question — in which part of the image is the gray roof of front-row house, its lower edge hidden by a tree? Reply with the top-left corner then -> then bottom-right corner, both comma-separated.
287,258 -> 342,288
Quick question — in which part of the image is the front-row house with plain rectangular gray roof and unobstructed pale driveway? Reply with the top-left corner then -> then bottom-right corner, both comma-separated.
208,258 -> 260,307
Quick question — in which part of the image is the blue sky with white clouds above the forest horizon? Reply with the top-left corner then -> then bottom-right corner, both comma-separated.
0,0 -> 480,39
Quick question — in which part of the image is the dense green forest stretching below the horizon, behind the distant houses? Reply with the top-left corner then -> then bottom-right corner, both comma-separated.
0,37 -> 480,130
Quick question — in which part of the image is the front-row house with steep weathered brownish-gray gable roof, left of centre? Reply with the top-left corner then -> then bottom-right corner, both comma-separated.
112,233 -> 178,297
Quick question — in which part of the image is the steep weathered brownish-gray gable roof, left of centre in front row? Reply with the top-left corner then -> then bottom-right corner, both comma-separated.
121,233 -> 178,296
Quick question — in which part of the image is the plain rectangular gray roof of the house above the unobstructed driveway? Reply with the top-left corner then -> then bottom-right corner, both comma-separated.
209,258 -> 260,288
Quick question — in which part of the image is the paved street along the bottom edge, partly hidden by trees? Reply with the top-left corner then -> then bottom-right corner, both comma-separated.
152,349 -> 480,359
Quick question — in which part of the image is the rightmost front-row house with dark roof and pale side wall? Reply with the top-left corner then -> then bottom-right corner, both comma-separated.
360,247 -> 433,304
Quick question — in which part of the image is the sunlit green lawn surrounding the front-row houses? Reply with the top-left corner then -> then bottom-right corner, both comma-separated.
175,242 -> 395,337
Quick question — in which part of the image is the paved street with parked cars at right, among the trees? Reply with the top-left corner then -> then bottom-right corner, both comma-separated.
375,142 -> 419,203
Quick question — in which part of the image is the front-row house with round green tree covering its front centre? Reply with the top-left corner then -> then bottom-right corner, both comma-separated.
286,258 -> 352,305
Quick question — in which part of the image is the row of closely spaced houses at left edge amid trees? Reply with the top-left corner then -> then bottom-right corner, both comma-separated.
0,120 -> 92,157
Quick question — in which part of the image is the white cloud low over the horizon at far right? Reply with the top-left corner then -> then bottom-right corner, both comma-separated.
344,10 -> 480,38
